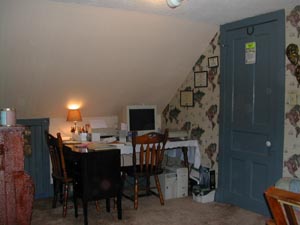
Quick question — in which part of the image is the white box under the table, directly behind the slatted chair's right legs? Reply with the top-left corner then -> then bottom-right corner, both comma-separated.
150,170 -> 177,199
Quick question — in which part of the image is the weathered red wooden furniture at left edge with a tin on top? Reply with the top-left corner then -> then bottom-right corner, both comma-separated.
0,126 -> 34,225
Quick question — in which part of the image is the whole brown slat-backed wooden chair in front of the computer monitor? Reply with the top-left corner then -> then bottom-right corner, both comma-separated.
124,130 -> 168,209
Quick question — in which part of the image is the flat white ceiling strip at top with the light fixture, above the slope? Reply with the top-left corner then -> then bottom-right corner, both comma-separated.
54,0 -> 300,25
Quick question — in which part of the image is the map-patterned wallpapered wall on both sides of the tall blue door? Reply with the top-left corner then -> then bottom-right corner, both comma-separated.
162,5 -> 300,183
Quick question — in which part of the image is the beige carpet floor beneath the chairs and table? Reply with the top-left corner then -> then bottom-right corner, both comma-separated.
31,196 -> 266,225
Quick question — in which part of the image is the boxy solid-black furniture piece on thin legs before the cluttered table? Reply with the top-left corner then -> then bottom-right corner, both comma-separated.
68,146 -> 123,225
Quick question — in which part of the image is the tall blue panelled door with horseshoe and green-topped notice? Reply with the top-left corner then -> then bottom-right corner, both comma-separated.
217,10 -> 285,215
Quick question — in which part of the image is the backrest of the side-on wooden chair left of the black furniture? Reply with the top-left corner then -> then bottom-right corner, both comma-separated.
45,132 -> 67,179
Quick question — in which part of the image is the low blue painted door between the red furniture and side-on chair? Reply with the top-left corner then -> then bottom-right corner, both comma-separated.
17,118 -> 53,199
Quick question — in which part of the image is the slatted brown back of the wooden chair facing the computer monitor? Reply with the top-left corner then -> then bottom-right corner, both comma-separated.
132,130 -> 168,175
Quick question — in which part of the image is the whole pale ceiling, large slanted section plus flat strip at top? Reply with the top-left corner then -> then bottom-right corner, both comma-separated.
0,0 -> 294,118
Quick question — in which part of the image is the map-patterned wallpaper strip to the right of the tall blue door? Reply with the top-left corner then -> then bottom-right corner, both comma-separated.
283,5 -> 300,178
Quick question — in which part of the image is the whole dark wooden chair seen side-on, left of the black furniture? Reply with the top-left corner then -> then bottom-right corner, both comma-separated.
45,132 -> 73,217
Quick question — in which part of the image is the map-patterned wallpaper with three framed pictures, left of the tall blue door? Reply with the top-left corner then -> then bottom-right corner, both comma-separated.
162,33 -> 220,179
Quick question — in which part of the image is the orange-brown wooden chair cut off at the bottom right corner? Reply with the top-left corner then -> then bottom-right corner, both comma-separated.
265,186 -> 300,225
